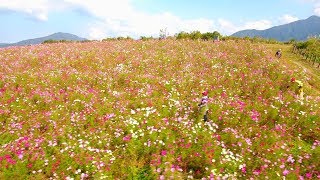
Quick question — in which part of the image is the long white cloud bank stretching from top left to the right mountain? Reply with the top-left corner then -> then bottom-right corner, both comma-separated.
0,0 -> 282,39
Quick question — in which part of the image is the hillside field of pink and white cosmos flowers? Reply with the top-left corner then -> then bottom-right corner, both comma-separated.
0,39 -> 320,179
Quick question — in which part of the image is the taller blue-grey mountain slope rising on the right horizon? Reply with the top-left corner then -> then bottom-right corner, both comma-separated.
231,16 -> 320,41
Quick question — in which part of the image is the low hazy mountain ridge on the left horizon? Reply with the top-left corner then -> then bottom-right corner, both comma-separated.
0,32 -> 87,47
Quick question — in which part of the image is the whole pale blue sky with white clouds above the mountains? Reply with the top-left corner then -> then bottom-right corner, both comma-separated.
0,0 -> 320,43
